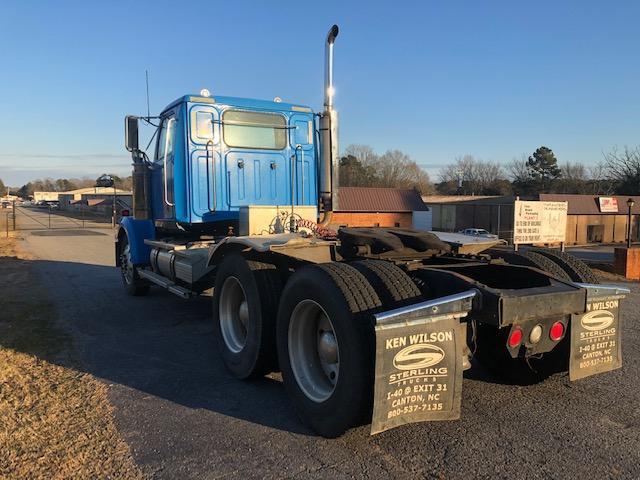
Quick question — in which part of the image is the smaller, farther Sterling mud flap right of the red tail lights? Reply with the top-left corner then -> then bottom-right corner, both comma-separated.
569,284 -> 629,381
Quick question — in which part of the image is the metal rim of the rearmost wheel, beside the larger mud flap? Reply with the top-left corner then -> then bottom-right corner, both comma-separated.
288,300 -> 340,403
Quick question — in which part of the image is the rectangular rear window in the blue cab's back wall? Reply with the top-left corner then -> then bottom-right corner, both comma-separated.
222,110 -> 287,150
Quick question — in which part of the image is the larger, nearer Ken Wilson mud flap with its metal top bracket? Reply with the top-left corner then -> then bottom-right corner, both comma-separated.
371,290 -> 476,435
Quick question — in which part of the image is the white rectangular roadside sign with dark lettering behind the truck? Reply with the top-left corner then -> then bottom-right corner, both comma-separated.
513,200 -> 567,245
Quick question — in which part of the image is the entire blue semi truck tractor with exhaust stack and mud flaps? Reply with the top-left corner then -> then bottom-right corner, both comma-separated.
115,25 -> 626,437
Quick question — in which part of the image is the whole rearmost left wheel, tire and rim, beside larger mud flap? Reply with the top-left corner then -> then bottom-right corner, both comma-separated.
277,263 -> 381,438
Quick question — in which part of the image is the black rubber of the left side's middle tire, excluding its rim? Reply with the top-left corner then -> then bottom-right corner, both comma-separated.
213,253 -> 282,379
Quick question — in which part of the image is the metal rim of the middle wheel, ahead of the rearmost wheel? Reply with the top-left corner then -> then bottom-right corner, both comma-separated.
218,277 -> 249,353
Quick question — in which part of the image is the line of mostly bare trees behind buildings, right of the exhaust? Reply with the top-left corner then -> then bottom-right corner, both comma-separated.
340,145 -> 640,196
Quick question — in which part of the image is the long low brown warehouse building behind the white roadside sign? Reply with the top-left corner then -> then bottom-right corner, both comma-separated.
423,193 -> 640,245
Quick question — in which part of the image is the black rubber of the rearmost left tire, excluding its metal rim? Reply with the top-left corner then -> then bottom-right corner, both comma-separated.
277,263 -> 381,438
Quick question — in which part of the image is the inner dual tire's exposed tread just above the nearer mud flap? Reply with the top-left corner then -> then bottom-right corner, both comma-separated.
349,260 -> 422,308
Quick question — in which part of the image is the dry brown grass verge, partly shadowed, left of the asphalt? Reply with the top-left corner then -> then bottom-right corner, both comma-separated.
0,238 -> 142,479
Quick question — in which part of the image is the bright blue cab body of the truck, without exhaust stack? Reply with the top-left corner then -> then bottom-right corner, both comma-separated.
121,90 -> 318,264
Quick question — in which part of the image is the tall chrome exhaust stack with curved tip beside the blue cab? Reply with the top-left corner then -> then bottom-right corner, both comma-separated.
320,25 -> 340,225
